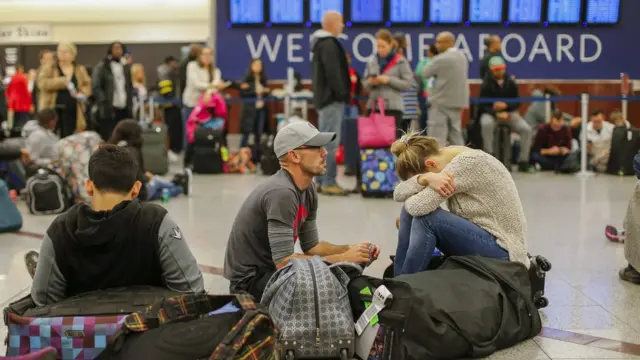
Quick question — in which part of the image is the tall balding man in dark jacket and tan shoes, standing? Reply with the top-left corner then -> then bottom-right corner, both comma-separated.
311,11 -> 351,195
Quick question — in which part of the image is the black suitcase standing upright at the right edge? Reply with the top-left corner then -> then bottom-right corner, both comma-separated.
607,126 -> 640,176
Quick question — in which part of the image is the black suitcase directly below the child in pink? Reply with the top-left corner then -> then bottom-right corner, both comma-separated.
193,127 -> 224,174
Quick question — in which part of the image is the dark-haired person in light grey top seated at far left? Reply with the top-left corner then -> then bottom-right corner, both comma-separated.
26,109 -> 60,167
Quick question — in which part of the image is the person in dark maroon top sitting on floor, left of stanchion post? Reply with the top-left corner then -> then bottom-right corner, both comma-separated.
531,112 -> 571,170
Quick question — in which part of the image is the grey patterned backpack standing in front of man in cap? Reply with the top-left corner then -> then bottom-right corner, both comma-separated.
261,256 -> 362,359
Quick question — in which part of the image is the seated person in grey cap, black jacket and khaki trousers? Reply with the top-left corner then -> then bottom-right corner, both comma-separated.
479,56 -> 532,171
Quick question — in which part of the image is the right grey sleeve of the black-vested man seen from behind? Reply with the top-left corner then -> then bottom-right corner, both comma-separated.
158,214 -> 204,293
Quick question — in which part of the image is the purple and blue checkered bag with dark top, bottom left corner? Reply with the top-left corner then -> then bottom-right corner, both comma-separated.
4,286 -> 176,360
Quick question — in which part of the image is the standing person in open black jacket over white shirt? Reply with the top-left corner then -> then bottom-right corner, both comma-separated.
93,41 -> 133,141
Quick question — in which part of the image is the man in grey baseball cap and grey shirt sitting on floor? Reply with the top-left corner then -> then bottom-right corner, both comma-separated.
224,121 -> 380,300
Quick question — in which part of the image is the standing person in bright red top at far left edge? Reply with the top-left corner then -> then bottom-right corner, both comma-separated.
6,65 -> 33,134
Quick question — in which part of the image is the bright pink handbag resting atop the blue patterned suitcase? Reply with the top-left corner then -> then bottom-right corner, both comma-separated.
358,98 -> 396,149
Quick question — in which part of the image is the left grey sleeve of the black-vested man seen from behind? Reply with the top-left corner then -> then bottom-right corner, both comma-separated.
31,234 -> 67,306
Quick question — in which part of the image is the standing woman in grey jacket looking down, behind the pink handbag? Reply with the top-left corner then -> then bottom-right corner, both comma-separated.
362,29 -> 413,137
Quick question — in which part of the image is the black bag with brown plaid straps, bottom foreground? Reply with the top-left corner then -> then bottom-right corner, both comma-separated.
98,294 -> 279,360
